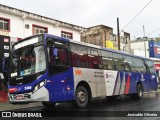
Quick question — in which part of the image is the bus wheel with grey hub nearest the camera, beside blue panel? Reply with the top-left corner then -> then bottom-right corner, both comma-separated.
74,86 -> 89,108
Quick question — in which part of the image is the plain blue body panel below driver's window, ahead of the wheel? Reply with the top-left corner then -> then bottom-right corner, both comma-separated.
46,68 -> 74,102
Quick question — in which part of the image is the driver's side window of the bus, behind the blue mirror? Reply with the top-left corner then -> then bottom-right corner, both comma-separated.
47,39 -> 70,74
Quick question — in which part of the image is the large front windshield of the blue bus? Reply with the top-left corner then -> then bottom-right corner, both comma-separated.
11,46 -> 46,77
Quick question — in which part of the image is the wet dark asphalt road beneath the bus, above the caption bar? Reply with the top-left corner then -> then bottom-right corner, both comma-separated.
10,92 -> 160,111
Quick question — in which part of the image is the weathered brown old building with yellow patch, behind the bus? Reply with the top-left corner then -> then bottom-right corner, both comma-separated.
81,25 -> 131,53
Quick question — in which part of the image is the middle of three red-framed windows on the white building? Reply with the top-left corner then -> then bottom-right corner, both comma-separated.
33,25 -> 48,35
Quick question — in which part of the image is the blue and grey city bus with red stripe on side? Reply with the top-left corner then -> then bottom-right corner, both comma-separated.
6,33 -> 157,108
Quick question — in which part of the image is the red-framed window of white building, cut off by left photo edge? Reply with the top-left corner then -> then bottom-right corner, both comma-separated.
0,17 -> 10,31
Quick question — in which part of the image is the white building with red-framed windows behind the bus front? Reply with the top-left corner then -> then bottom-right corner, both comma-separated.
0,4 -> 85,41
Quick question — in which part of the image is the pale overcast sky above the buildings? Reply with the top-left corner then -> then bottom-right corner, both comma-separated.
0,0 -> 160,39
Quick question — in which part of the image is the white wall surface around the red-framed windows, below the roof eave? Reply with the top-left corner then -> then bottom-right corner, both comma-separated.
0,11 -> 81,41
